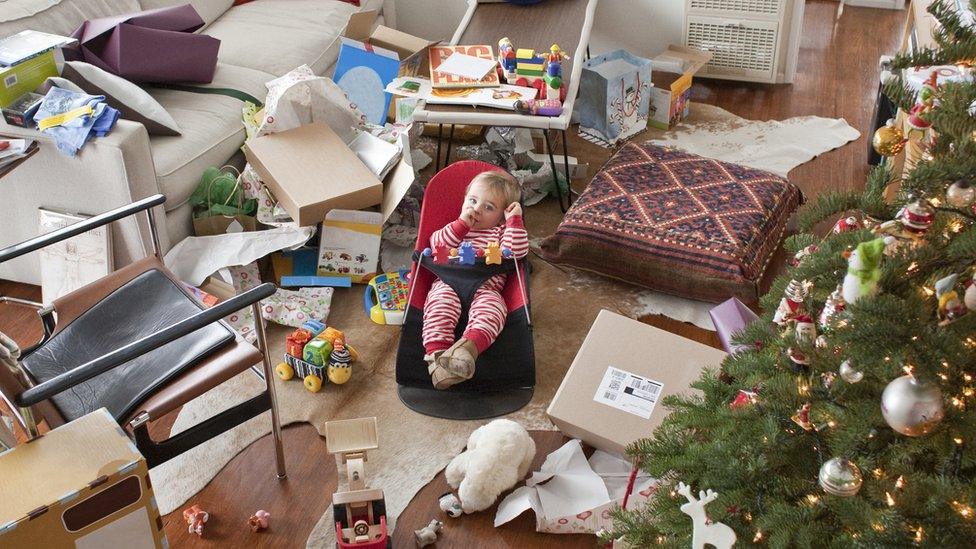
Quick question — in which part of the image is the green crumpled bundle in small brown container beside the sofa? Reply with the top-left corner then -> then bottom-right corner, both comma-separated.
190,166 -> 258,236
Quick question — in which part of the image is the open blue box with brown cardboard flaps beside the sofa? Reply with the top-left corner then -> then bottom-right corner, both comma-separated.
340,10 -> 439,125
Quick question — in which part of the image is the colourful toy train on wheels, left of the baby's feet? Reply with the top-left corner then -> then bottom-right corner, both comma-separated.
275,320 -> 359,393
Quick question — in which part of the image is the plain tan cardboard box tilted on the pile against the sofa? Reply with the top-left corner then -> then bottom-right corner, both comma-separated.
244,122 -> 383,226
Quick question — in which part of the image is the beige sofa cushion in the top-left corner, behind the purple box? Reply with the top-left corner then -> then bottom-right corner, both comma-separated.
0,0 -> 142,37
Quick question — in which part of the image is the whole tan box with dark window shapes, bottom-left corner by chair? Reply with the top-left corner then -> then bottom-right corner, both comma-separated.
0,408 -> 168,549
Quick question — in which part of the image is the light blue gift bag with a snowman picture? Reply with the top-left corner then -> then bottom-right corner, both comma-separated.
576,50 -> 651,146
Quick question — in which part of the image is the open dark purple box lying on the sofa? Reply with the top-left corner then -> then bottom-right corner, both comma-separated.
65,4 -> 220,84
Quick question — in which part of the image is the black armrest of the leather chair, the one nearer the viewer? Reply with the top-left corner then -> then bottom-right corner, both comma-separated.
16,282 -> 277,407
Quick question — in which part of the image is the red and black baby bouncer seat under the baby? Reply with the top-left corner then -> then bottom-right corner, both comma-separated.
396,160 -> 535,419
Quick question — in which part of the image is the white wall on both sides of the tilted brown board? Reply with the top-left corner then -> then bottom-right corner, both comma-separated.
386,0 -> 685,57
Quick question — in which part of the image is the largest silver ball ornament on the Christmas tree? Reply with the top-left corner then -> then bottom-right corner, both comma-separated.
881,374 -> 945,437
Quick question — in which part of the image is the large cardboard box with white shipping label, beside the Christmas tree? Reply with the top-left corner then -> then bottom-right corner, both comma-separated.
546,310 -> 726,455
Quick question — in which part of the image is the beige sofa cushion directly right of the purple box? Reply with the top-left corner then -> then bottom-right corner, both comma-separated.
204,0 -> 382,76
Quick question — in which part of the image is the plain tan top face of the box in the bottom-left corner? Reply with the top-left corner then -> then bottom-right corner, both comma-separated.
0,408 -> 143,525
